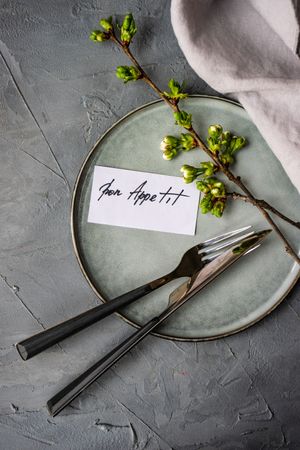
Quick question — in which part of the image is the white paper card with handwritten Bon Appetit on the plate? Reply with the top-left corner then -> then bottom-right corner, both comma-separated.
88,166 -> 199,235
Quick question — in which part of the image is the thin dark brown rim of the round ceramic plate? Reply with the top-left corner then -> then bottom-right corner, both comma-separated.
70,94 -> 300,342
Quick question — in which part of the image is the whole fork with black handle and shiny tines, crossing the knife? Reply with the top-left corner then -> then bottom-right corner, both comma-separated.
16,226 -> 253,360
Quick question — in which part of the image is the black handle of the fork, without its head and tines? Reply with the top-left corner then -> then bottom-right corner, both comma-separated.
16,274 -> 172,360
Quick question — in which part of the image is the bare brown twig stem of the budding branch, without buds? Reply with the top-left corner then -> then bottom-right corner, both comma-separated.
111,32 -> 300,264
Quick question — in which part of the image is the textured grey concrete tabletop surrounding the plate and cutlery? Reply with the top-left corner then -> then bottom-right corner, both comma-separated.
0,0 -> 300,450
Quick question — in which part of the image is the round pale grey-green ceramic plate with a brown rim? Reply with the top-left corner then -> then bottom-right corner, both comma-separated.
72,96 -> 299,340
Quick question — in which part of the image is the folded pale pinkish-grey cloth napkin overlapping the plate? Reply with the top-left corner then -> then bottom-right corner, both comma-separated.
171,0 -> 300,192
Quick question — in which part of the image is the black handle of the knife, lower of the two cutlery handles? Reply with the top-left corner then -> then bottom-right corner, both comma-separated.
47,317 -> 159,416
